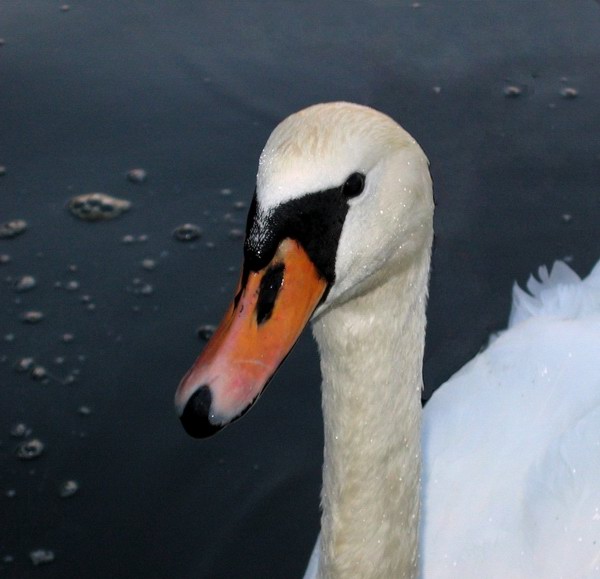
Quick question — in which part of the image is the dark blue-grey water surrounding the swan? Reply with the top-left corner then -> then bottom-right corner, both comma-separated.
0,0 -> 600,579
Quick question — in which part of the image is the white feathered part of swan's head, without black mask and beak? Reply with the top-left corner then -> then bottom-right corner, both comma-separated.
256,102 -> 433,314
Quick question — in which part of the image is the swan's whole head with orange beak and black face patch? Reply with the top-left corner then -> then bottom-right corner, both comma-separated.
175,103 -> 433,437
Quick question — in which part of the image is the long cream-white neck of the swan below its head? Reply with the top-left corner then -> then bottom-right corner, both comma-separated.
313,251 -> 429,579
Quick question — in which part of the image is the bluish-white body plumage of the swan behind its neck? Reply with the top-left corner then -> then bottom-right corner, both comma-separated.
421,262 -> 600,579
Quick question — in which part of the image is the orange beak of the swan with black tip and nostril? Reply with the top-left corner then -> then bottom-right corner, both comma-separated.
175,239 -> 327,438
